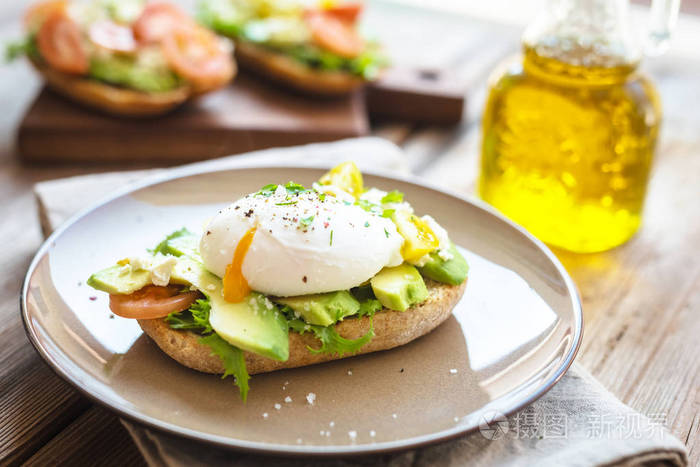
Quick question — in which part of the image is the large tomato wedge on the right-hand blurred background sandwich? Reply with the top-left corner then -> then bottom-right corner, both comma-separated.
306,11 -> 365,58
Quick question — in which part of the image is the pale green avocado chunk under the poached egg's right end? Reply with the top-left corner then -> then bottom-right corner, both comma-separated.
370,263 -> 428,311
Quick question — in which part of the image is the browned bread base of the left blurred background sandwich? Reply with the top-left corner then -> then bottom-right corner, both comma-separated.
30,60 -> 193,117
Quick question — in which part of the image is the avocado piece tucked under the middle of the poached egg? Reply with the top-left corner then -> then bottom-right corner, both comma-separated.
275,290 -> 360,326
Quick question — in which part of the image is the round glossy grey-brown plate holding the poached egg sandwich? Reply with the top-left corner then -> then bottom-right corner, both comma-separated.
21,166 -> 582,455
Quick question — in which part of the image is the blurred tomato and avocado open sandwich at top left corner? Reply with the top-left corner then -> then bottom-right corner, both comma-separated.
11,0 -> 236,116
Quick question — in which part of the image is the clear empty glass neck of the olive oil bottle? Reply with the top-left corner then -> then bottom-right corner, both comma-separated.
523,0 -> 641,71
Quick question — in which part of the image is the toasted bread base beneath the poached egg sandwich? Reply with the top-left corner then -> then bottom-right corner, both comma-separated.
138,280 -> 467,375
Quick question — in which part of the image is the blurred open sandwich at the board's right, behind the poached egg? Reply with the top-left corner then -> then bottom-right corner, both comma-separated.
199,0 -> 386,96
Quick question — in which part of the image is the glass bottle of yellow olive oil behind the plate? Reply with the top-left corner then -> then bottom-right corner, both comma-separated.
479,0 -> 678,252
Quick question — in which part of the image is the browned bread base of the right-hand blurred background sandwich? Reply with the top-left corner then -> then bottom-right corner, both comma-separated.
235,41 -> 365,97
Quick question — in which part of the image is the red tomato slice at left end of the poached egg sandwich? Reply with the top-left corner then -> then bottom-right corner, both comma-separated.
109,285 -> 202,319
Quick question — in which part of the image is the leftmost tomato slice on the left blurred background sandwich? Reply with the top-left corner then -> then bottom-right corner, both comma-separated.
36,11 -> 89,75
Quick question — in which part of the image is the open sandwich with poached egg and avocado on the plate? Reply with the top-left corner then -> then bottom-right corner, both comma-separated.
88,163 -> 468,399
